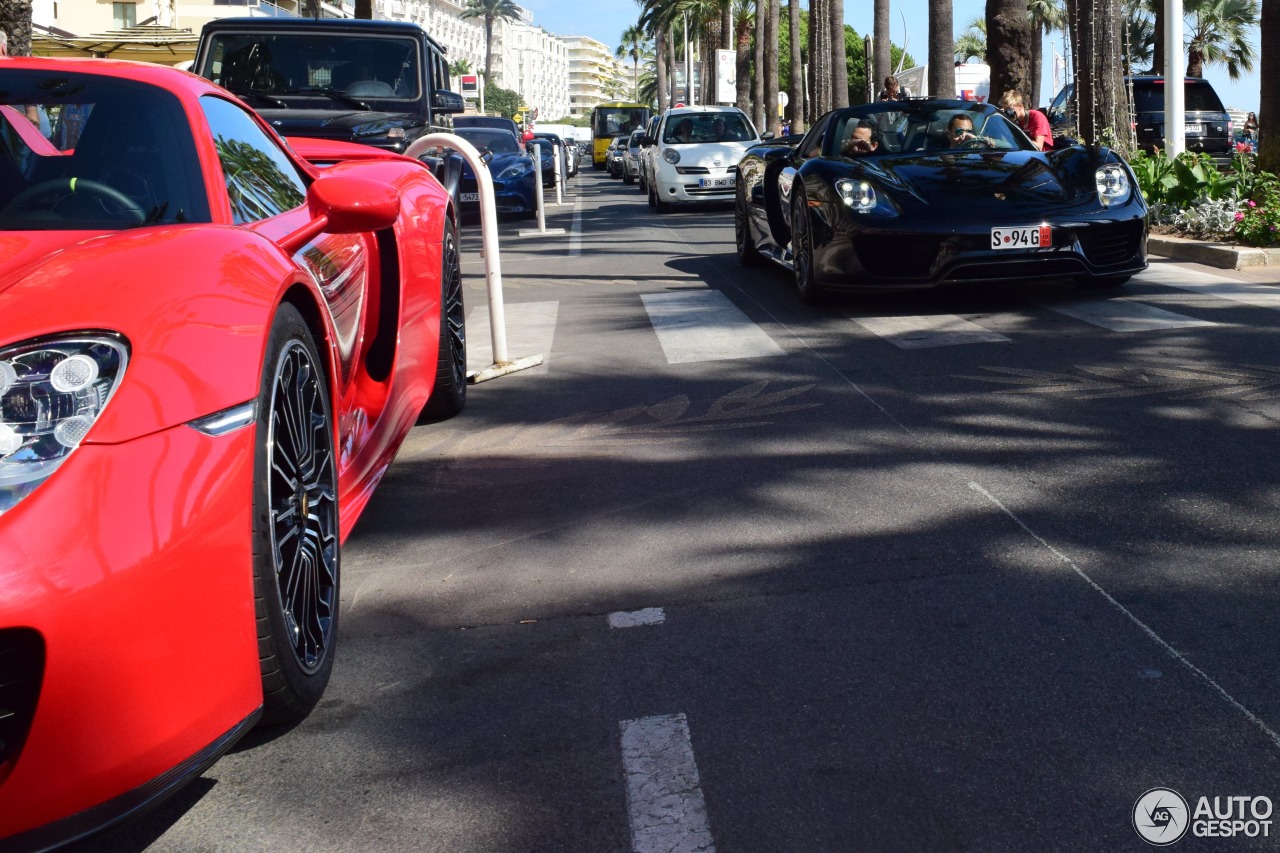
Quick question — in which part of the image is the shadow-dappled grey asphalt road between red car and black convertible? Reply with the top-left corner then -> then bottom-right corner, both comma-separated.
78,170 -> 1280,853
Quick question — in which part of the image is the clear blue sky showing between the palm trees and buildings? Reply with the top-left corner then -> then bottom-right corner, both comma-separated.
516,0 -> 1259,111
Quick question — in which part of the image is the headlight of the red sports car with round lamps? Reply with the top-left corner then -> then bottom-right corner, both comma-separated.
0,333 -> 129,514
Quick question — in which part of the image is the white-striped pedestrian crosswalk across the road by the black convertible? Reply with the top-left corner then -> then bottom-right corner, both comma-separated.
467,264 -> 1280,373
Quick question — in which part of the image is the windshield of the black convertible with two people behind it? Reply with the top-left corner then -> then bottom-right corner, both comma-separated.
823,101 -> 1036,156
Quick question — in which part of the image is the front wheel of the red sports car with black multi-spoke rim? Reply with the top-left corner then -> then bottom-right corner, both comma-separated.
253,305 -> 340,725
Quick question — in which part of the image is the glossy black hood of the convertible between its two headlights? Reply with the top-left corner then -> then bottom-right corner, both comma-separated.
854,149 -> 1096,212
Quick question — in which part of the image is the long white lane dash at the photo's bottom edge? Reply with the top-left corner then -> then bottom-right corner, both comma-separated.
621,713 -> 716,853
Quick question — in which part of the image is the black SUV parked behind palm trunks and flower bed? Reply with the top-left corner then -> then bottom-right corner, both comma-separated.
1044,76 -> 1235,164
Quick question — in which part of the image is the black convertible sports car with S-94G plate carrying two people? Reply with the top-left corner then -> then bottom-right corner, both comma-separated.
733,99 -> 1147,302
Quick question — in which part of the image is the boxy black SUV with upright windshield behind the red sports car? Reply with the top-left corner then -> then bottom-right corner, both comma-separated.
192,18 -> 463,152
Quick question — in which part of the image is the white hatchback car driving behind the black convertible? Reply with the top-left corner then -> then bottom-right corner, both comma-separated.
645,106 -> 760,213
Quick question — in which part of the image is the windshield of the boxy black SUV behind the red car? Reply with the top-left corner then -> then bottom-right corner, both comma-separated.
198,32 -> 420,99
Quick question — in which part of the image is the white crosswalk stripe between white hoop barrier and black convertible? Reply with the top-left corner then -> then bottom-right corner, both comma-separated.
640,289 -> 786,364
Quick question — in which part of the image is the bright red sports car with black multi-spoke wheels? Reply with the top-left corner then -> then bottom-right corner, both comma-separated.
0,59 -> 466,850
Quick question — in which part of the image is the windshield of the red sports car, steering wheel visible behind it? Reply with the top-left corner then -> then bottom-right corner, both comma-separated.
0,67 -> 210,231
